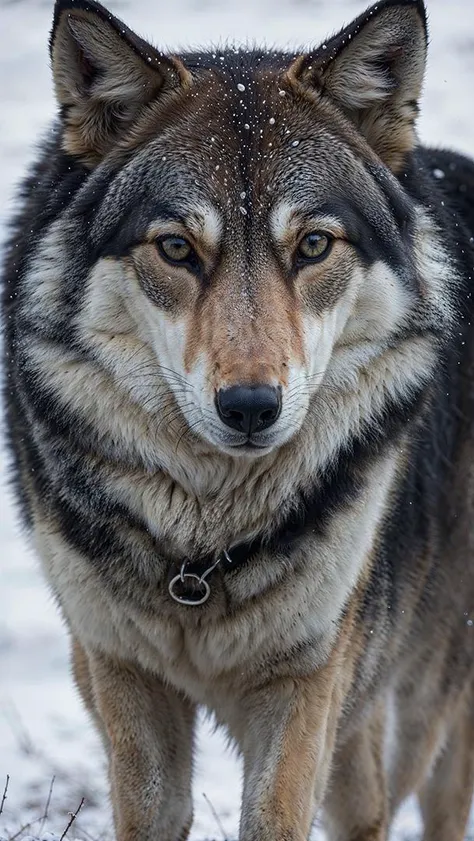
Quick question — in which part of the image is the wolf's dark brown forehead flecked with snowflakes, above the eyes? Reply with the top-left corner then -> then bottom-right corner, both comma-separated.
112,69 -> 408,249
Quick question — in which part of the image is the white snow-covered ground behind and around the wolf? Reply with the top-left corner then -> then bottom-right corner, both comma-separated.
0,0 -> 474,841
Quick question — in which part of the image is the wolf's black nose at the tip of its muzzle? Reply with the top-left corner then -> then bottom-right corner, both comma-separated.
216,385 -> 281,435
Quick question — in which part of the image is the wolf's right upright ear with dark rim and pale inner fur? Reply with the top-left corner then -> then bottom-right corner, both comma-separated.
289,0 -> 428,172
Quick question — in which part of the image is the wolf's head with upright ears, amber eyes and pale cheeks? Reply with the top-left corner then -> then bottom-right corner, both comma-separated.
43,0 -> 444,457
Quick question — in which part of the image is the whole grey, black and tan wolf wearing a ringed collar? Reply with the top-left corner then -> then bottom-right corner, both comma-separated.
3,0 -> 474,841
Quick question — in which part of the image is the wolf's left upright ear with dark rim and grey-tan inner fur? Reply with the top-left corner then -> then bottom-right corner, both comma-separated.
50,0 -> 190,166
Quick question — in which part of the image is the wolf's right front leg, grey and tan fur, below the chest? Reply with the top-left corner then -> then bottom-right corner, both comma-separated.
239,666 -> 341,841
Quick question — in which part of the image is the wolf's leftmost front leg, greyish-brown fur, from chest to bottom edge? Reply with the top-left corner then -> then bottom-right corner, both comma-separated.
77,654 -> 195,841
